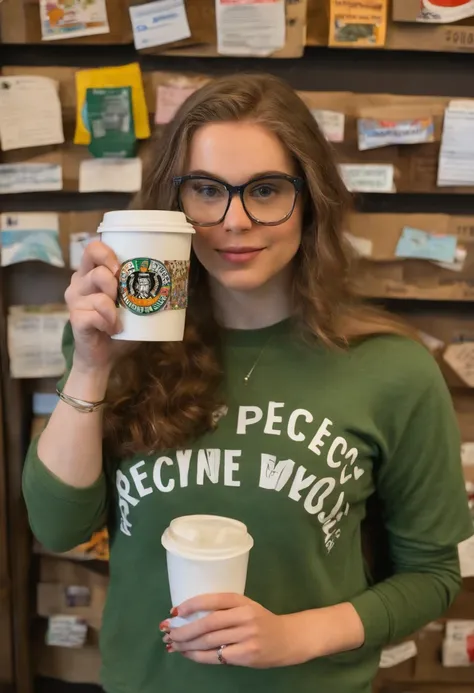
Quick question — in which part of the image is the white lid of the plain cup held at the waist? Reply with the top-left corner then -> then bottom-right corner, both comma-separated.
161,515 -> 253,561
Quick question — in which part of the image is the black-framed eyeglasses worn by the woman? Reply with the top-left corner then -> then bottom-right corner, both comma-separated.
173,173 -> 304,226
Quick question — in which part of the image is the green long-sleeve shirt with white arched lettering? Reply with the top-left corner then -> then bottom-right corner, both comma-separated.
24,321 -> 473,693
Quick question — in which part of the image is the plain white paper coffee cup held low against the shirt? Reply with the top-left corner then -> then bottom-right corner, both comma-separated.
161,515 -> 253,626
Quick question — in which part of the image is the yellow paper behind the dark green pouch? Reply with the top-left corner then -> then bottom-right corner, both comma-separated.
74,63 -> 150,145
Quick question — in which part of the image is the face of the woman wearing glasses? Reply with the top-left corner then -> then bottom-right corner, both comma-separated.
185,122 -> 302,291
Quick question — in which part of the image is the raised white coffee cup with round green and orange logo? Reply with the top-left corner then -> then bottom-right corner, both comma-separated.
97,210 -> 194,342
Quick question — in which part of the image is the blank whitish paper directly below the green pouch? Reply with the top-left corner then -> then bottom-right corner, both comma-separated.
79,159 -> 142,192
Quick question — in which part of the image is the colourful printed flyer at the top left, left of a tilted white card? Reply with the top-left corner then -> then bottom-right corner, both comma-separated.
39,0 -> 109,41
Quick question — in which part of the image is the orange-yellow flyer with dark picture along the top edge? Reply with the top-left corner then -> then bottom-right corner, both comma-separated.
329,0 -> 388,48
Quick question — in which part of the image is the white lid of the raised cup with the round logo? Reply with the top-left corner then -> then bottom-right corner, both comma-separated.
97,209 -> 195,233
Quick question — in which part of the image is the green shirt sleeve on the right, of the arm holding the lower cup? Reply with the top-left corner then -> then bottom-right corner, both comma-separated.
351,360 -> 474,647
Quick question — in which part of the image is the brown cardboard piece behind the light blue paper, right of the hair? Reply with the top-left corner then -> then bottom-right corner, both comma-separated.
347,214 -> 474,301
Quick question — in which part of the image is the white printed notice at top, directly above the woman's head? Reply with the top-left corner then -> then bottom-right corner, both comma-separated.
216,0 -> 286,57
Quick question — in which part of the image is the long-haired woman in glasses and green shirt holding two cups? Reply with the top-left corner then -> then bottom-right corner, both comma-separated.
24,76 -> 472,693
